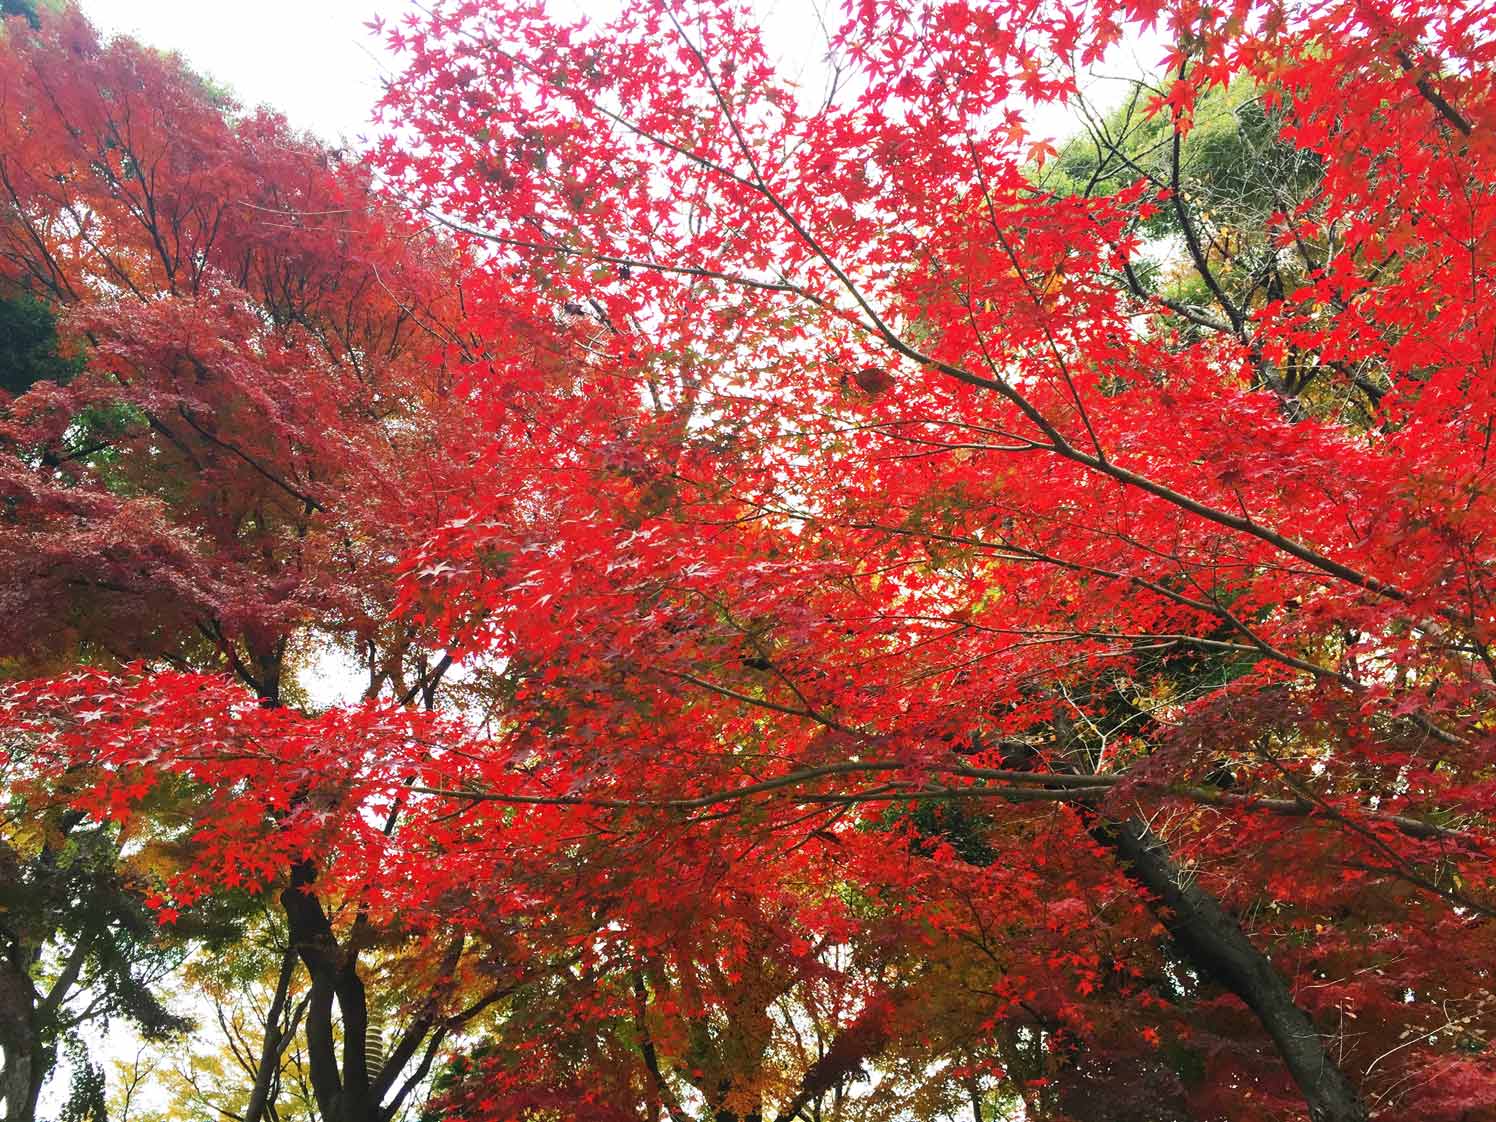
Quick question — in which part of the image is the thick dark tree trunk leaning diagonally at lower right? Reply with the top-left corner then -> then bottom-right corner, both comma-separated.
1091,818 -> 1367,1122
